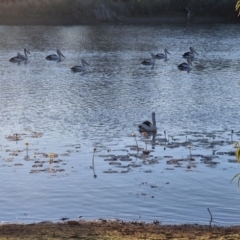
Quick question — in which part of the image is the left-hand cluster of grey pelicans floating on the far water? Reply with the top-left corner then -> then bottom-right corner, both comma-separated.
9,48 -> 90,72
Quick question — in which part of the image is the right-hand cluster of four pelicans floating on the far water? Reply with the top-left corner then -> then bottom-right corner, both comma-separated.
141,47 -> 198,73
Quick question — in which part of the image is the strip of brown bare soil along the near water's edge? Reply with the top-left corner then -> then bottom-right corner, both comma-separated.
0,220 -> 240,240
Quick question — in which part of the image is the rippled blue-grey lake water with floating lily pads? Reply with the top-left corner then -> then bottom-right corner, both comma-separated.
0,24 -> 240,225
